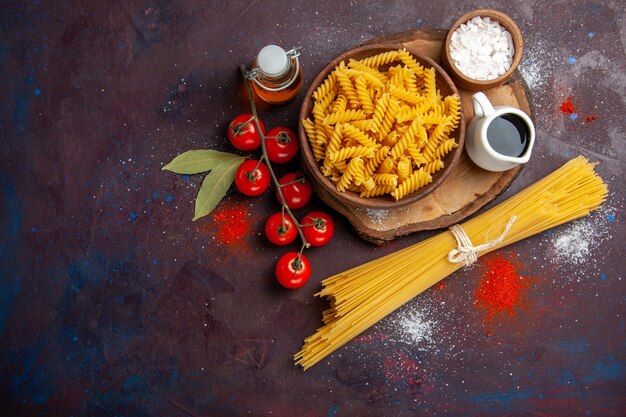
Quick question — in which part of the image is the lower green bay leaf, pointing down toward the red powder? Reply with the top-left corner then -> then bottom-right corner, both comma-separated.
193,155 -> 245,221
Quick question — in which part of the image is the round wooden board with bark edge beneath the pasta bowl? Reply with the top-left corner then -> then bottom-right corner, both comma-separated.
314,30 -> 534,244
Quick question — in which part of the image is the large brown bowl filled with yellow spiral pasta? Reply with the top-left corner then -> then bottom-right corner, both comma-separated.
299,44 -> 465,209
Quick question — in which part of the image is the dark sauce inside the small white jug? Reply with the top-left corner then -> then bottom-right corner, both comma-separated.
487,114 -> 529,158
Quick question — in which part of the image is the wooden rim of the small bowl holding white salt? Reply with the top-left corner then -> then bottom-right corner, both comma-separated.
444,8 -> 524,87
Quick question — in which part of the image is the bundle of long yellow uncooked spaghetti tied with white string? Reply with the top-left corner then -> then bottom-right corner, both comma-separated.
294,156 -> 608,369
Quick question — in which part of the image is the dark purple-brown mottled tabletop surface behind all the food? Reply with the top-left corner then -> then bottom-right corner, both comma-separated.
0,0 -> 626,417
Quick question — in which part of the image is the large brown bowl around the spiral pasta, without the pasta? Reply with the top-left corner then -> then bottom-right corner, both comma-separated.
298,44 -> 465,209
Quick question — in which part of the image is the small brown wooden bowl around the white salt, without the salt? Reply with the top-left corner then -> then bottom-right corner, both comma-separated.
441,9 -> 524,91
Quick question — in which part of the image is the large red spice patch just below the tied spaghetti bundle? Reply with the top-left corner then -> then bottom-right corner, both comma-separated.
474,254 -> 530,323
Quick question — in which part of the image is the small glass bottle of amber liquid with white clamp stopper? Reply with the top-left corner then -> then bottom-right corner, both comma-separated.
247,45 -> 302,104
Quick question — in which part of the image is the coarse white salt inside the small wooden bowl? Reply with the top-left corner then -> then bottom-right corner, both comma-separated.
450,16 -> 515,80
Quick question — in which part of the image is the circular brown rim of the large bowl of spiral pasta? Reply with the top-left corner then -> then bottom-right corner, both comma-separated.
298,43 -> 465,209
